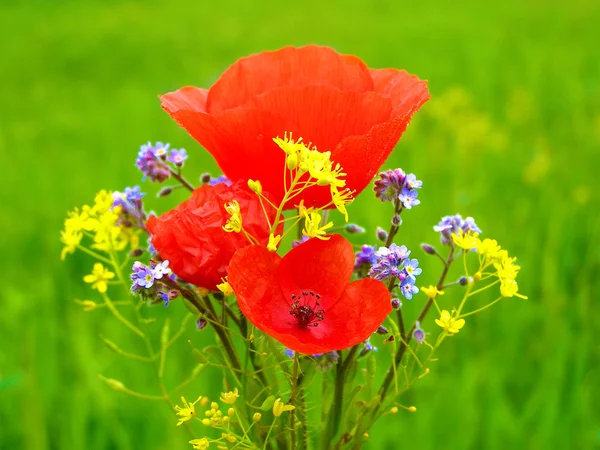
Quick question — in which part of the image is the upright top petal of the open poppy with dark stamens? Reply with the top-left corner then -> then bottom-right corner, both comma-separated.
277,234 -> 354,309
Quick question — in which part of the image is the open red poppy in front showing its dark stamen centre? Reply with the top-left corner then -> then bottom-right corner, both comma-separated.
228,235 -> 392,354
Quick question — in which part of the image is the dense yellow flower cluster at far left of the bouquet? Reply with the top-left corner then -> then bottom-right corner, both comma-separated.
60,190 -> 139,259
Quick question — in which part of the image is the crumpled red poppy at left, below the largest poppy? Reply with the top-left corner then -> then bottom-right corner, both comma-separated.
146,181 -> 281,290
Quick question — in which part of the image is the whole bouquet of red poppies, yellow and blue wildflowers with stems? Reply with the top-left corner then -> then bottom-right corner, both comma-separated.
61,46 -> 524,449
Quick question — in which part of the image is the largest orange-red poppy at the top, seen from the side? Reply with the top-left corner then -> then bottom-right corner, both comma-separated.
161,45 -> 429,208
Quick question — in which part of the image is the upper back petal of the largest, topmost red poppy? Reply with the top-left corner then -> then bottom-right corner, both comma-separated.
207,45 -> 374,114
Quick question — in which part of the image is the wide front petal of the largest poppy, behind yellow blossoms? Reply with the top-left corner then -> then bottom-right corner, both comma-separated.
163,86 -> 396,207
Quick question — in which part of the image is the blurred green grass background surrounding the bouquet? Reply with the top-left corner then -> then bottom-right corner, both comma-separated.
0,0 -> 600,450
